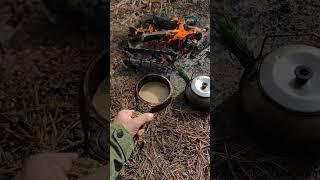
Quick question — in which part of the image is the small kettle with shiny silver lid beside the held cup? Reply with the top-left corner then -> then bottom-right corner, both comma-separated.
185,76 -> 210,112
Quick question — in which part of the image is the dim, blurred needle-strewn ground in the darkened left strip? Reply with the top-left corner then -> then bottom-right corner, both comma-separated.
0,1 -> 104,176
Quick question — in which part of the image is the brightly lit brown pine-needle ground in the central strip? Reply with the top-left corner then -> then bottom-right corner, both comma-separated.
111,0 -> 210,179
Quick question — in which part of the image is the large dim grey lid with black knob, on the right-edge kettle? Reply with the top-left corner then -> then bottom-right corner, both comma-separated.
259,45 -> 320,113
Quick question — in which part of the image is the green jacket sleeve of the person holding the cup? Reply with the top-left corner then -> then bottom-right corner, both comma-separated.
110,123 -> 134,180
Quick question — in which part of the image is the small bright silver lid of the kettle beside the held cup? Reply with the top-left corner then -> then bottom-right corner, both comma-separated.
191,76 -> 210,98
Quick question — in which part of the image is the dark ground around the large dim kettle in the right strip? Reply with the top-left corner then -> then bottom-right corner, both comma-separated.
210,0 -> 320,179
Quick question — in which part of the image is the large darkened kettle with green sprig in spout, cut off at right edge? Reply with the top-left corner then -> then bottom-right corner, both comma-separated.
218,21 -> 320,153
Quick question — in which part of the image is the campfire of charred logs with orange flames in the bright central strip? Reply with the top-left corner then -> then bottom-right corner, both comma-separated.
125,16 -> 209,72
